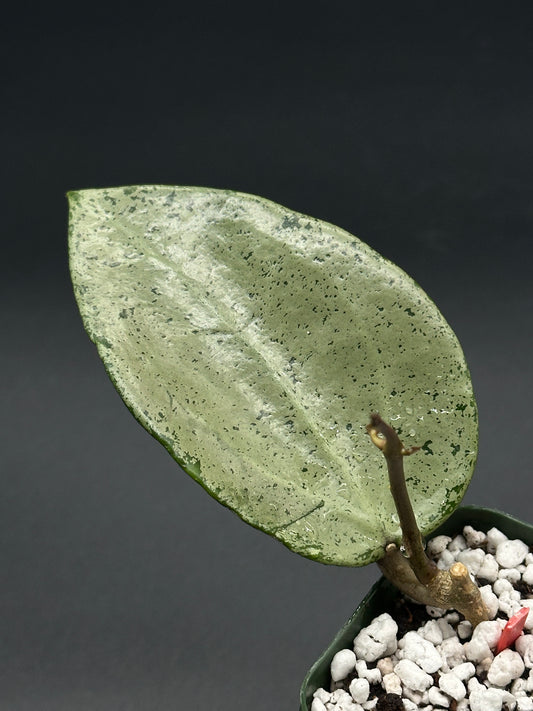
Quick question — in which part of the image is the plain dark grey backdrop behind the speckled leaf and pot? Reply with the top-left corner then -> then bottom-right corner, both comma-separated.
0,2 -> 533,711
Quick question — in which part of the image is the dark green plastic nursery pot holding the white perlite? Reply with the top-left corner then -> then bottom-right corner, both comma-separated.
300,506 -> 533,711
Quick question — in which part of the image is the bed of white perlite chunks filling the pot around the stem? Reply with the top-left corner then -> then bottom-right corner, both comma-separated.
318,526 -> 533,711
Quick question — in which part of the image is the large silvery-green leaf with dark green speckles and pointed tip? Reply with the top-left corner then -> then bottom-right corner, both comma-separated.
69,186 -> 477,565
